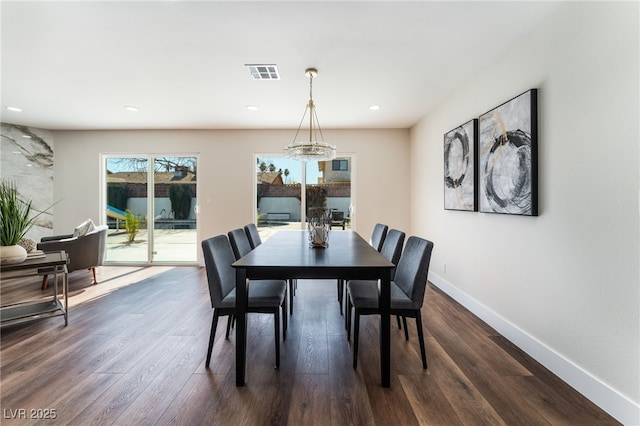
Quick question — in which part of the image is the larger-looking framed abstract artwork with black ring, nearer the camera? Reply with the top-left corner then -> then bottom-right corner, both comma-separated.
478,89 -> 538,216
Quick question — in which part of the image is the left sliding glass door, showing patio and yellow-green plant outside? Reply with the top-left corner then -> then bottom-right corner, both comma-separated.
104,155 -> 198,264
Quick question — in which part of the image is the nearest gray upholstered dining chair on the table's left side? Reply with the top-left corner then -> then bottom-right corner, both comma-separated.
202,235 -> 287,368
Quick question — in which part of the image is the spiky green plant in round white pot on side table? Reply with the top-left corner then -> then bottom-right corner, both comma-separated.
0,179 -> 42,264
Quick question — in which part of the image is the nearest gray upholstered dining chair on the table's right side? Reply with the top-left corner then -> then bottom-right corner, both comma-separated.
347,236 -> 433,370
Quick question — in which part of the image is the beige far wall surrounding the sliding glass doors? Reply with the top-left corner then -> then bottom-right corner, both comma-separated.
54,129 -> 410,264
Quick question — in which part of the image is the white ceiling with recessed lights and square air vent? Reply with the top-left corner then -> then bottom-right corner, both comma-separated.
0,0 -> 560,130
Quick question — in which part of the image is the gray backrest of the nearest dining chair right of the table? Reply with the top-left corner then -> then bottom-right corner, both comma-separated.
394,236 -> 433,309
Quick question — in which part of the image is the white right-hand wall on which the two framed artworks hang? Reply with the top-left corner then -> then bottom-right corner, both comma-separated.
411,2 -> 640,424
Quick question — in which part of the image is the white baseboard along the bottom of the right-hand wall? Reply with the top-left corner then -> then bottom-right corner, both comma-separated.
429,272 -> 640,425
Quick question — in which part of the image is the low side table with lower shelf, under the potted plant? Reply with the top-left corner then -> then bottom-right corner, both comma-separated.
0,251 -> 69,327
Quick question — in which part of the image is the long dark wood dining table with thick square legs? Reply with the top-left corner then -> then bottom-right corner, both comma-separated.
232,230 -> 394,387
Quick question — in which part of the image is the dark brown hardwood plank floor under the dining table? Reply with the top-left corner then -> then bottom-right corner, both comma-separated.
0,267 -> 617,426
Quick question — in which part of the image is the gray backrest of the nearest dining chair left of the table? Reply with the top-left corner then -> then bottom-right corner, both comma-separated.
202,235 -> 236,308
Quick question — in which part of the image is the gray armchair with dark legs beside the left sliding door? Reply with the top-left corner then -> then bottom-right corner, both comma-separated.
38,225 -> 108,289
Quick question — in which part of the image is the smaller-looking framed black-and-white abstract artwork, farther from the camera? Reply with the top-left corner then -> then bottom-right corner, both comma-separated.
444,119 -> 478,211
